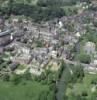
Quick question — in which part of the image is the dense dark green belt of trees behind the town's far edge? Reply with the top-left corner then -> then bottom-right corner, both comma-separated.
0,0 -> 65,22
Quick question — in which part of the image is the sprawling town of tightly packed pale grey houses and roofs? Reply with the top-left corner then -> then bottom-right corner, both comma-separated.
0,1 -> 97,75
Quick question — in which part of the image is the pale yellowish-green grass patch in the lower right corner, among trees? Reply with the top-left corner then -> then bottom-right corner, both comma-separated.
66,74 -> 97,98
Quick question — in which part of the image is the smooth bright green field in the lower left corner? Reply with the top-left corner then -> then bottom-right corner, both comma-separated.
0,81 -> 49,100
